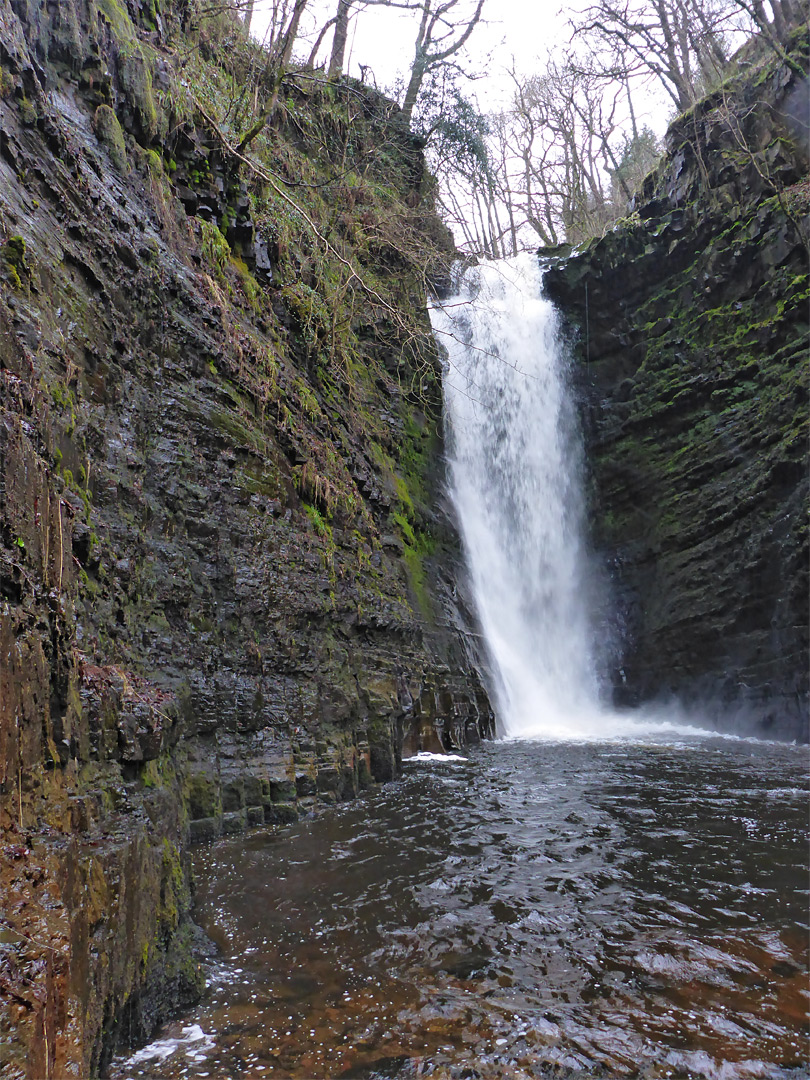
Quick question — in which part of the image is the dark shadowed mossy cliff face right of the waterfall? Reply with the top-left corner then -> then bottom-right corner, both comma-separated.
546,37 -> 810,739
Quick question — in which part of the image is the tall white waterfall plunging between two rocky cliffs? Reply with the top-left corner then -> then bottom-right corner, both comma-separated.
431,255 -> 602,738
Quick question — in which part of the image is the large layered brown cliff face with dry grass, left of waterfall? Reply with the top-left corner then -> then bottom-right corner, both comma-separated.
0,0 -> 491,1077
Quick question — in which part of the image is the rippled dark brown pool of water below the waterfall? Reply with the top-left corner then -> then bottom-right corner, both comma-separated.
113,739 -> 810,1080
